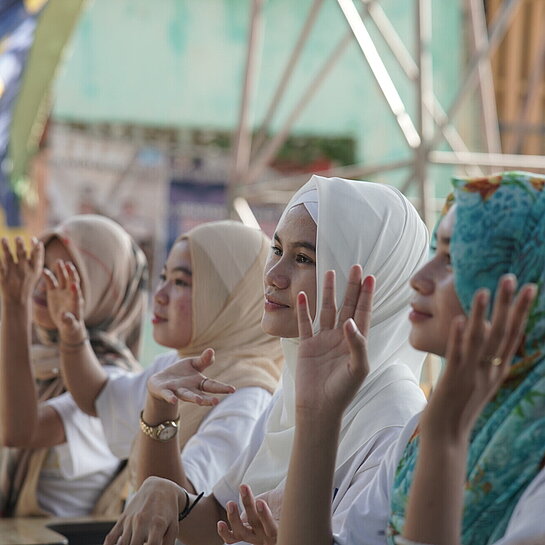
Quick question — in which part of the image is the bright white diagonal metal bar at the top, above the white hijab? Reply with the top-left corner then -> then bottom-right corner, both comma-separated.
337,0 -> 420,149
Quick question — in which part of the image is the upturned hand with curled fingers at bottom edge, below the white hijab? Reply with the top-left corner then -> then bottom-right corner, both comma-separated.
218,484 -> 282,545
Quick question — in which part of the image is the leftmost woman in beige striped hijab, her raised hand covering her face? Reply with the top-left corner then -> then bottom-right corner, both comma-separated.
0,215 -> 147,516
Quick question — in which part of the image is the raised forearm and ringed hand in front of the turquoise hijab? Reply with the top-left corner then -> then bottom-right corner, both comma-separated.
404,275 -> 536,545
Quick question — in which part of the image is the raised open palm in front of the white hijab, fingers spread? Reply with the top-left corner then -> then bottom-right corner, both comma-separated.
296,265 -> 375,418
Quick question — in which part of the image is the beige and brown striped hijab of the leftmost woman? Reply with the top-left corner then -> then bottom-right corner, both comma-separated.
0,215 -> 148,516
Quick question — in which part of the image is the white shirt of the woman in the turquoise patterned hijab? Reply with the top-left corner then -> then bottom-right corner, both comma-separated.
334,415 -> 545,545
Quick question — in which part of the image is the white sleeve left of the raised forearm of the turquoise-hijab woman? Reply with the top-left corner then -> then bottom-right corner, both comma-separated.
333,415 -> 420,545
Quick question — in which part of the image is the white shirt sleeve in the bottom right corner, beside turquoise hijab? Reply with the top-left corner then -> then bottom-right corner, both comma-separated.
494,469 -> 545,545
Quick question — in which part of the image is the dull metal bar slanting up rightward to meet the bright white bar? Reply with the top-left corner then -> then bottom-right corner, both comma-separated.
245,32 -> 352,183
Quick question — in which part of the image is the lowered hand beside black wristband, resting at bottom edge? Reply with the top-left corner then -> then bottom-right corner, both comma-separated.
104,477 -> 187,545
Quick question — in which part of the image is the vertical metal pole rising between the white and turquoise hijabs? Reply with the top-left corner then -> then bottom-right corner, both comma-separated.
414,0 -> 433,226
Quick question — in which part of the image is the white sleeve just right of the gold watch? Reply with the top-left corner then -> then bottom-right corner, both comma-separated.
180,387 -> 271,494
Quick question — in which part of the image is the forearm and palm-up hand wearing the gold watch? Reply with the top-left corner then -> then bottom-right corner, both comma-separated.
134,349 -> 235,493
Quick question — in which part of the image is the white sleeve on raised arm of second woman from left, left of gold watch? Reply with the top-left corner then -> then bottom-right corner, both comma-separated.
95,352 -> 179,459
